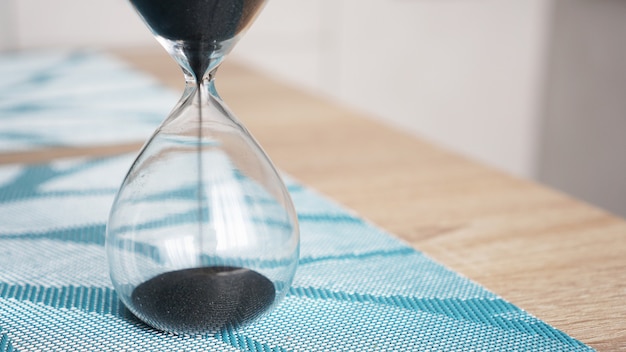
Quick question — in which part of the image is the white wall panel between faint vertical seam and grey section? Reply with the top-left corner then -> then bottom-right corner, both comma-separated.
332,0 -> 548,176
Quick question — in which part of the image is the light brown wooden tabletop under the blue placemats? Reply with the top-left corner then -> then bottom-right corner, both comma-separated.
6,48 -> 626,351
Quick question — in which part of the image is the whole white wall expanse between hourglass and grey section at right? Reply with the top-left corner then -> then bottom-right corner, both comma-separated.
234,0 -> 550,177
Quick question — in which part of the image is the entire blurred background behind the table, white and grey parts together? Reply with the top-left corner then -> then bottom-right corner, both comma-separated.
0,0 -> 626,216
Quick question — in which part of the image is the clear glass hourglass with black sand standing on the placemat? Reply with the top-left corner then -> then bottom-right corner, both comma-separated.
106,0 -> 299,334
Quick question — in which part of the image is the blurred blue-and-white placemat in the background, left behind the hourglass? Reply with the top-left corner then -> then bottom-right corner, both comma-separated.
0,51 -> 176,153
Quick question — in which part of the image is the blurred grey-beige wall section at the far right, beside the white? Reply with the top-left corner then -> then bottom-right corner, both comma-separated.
538,0 -> 626,217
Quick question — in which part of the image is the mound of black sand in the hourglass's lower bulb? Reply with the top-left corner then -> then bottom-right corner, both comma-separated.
132,267 -> 276,334
